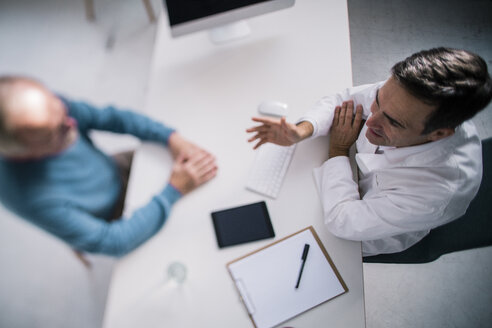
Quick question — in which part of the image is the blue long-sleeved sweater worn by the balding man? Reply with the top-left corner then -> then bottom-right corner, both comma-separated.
0,98 -> 180,256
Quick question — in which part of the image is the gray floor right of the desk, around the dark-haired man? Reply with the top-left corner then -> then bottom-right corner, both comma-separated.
348,0 -> 492,328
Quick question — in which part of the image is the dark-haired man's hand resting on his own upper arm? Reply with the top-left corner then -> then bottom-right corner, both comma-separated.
329,100 -> 364,158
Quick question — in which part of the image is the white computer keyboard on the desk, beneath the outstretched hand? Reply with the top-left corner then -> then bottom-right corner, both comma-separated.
246,143 -> 296,198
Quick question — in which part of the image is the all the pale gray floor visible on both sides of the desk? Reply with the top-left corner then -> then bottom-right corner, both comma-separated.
0,0 -> 492,328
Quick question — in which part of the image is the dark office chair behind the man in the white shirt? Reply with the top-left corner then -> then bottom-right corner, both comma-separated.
363,138 -> 492,263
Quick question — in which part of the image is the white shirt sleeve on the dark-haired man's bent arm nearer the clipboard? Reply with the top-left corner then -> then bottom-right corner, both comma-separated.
314,156 -> 453,241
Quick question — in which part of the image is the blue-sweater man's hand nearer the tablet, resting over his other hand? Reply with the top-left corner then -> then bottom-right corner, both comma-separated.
169,150 -> 217,195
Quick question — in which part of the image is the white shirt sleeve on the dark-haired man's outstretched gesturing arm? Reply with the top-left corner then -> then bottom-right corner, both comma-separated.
298,81 -> 385,138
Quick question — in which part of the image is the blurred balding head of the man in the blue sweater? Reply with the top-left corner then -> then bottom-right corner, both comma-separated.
0,77 -> 77,158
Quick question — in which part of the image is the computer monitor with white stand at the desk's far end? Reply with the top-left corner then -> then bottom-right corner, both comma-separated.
164,0 -> 295,43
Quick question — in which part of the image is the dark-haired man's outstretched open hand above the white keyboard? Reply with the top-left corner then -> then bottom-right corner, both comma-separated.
246,117 -> 313,149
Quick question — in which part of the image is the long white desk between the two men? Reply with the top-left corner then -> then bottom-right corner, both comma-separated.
104,0 -> 365,328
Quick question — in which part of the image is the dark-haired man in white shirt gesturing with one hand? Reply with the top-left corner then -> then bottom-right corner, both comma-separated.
247,48 -> 492,256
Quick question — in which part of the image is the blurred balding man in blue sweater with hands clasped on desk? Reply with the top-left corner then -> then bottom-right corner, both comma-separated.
0,76 -> 217,256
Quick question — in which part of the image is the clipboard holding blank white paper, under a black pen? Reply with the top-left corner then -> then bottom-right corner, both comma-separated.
226,226 -> 348,328
